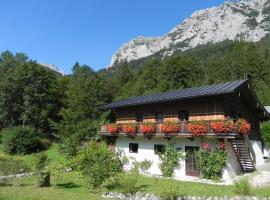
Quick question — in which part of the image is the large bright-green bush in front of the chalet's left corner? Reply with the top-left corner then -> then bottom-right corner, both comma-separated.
77,141 -> 122,191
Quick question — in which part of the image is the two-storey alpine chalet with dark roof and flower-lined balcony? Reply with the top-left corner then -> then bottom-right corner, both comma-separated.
100,80 -> 269,180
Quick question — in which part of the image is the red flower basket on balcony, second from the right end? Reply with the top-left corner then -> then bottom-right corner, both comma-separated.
211,120 -> 234,134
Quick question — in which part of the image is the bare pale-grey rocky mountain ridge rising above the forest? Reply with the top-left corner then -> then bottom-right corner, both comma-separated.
110,0 -> 270,66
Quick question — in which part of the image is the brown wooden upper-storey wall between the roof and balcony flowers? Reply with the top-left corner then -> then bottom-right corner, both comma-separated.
116,97 -> 224,124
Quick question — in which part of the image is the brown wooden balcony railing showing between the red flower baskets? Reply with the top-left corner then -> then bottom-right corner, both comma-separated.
100,120 -> 237,137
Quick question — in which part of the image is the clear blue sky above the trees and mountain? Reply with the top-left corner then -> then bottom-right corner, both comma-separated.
0,0 -> 224,74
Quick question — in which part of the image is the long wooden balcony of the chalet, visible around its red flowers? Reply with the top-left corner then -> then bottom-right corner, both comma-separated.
99,121 -> 238,138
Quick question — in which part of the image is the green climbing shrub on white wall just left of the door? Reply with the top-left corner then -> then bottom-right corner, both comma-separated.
159,144 -> 184,177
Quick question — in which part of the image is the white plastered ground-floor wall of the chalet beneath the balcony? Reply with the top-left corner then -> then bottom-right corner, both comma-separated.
116,136 -> 241,181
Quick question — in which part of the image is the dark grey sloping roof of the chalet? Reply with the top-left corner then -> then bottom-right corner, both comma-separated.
102,79 -> 248,109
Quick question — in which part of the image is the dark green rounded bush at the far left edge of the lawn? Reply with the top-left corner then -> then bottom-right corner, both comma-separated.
1,126 -> 44,154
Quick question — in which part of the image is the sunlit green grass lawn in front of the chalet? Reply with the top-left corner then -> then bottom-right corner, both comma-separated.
0,144 -> 270,200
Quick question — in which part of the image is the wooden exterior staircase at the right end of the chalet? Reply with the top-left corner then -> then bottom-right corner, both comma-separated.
231,138 -> 255,173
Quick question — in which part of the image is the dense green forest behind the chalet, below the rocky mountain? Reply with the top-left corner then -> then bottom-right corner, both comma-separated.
0,36 -> 270,156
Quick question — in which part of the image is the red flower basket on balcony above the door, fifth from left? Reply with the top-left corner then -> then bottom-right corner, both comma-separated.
187,121 -> 208,136
